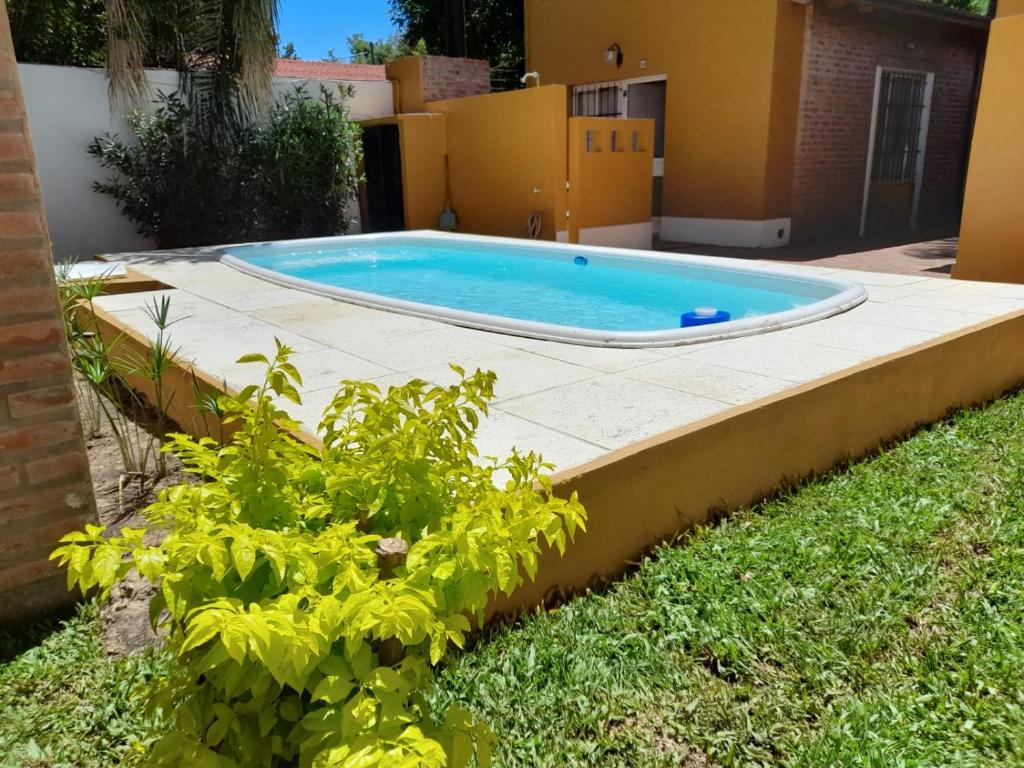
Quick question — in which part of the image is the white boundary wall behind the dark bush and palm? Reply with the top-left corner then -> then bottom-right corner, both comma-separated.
18,63 -> 393,259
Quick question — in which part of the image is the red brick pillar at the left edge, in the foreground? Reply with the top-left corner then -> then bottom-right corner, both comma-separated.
0,1 -> 94,625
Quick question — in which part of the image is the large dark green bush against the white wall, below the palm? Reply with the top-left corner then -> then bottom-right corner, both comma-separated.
88,88 -> 362,248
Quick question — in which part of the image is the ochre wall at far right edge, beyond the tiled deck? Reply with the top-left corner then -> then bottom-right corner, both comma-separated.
953,7 -> 1024,283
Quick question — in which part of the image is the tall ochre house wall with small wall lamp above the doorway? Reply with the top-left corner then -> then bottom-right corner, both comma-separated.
525,0 -> 806,219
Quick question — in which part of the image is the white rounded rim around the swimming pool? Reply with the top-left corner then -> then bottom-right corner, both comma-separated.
217,230 -> 867,348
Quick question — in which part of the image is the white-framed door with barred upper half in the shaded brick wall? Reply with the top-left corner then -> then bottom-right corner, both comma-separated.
860,68 -> 934,236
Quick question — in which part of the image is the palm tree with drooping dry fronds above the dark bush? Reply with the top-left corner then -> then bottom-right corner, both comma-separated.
105,0 -> 278,132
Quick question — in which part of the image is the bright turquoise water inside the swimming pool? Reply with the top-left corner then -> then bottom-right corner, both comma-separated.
227,238 -> 838,332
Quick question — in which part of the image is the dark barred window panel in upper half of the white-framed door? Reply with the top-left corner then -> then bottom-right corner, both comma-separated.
871,72 -> 928,184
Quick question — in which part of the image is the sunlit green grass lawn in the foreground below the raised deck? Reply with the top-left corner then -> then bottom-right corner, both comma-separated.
6,395 -> 1024,768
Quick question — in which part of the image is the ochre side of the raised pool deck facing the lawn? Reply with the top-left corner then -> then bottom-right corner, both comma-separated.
493,312 -> 1024,614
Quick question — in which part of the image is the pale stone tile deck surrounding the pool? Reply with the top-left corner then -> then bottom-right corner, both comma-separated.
96,252 -> 1024,469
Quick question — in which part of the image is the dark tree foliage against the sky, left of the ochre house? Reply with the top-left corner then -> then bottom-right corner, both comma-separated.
389,0 -> 525,89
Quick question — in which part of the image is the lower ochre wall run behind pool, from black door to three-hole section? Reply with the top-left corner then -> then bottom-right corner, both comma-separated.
364,86 -> 653,242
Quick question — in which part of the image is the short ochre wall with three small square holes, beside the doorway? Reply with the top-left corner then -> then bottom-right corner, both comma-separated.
569,118 -> 654,243
